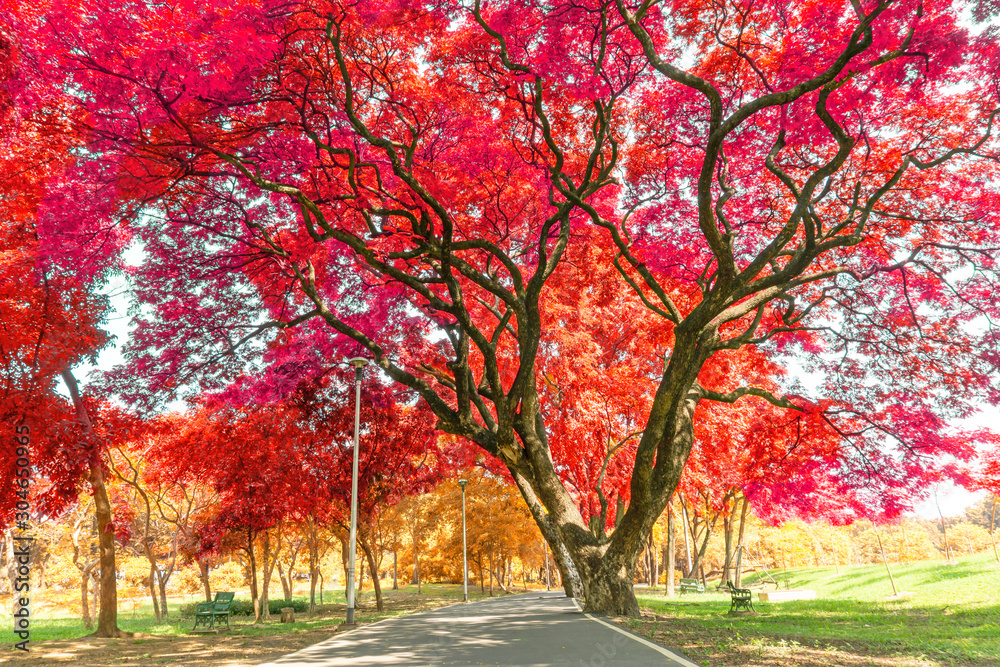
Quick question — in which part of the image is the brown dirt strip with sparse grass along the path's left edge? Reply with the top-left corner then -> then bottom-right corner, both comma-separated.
0,595 -> 464,667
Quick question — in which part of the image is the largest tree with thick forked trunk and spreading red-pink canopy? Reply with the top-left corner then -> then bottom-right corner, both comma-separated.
31,0 -> 1000,615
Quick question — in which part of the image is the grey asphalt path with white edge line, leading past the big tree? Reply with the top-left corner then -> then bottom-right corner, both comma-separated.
259,592 -> 697,667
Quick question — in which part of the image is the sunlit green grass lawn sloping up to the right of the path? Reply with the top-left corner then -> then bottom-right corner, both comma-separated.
639,554 -> 1000,665
